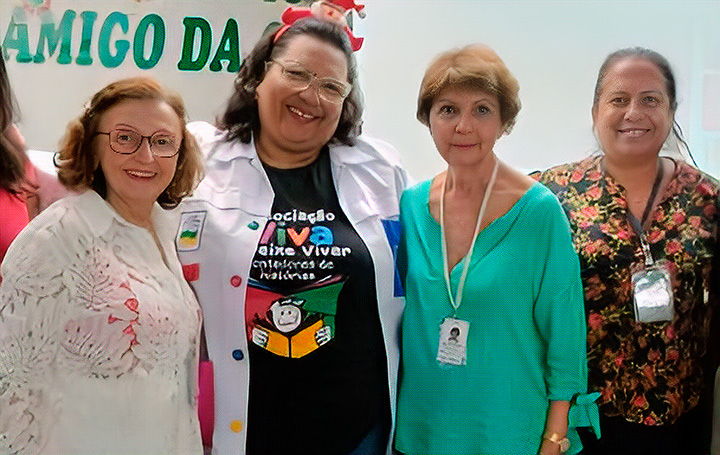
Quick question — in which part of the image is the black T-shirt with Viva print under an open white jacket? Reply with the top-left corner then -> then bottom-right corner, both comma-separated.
245,148 -> 389,454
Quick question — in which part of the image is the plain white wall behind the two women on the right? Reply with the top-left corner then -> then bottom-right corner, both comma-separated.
356,0 -> 720,179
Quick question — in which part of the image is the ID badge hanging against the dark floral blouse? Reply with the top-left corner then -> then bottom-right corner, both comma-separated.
632,262 -> 675,322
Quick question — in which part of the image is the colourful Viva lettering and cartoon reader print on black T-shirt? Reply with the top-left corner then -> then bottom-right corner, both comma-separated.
245,209 -> 352,358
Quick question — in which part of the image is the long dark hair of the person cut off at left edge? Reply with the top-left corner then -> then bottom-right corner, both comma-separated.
0,49 -> 25,193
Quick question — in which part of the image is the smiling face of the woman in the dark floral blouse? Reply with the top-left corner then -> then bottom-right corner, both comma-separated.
592,57 -> 674,162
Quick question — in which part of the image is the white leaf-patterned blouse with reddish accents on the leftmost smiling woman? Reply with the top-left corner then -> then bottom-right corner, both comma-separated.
0,191 -> 202,455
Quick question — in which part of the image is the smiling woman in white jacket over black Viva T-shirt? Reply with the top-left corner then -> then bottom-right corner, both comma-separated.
177,19 -> 406,454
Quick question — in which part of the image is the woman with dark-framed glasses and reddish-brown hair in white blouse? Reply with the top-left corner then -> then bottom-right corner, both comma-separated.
0,78 -> 202,455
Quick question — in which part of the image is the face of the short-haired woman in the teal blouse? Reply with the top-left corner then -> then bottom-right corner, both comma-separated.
429,86 -> 503,166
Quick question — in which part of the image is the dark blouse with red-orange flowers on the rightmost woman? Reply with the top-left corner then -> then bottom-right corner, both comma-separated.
539,155 -> 720,425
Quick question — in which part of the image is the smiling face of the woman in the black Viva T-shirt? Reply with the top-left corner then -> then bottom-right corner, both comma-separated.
257,35 -> 348,167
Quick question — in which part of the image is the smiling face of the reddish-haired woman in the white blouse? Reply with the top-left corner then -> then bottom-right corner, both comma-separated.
95,99 -> 183,219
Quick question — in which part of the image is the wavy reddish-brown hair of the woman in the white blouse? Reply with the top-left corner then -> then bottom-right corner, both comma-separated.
55,77 -> 202,209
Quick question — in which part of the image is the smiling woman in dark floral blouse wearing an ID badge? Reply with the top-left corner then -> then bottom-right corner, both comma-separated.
540,48 -> 720,455
